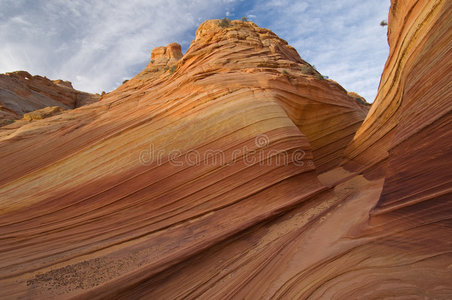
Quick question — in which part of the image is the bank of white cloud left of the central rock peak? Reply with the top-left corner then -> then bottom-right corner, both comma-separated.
0,0 -> 233,92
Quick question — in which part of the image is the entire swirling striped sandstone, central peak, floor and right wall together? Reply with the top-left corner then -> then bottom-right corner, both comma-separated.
0,0 -> 452,299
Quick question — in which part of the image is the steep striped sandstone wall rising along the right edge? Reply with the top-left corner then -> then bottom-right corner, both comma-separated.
347,1 -> 452,226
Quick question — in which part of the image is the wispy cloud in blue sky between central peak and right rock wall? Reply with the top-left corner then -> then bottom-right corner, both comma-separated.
245,0 -> 390,101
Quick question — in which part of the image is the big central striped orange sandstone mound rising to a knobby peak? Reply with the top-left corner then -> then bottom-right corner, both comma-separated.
0,20 -> 367,297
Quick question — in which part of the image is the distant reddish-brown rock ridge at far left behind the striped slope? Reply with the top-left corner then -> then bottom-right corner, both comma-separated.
0,71 -> 100,126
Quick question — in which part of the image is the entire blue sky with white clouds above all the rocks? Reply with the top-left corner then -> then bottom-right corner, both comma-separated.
0,0 -> 390,102
